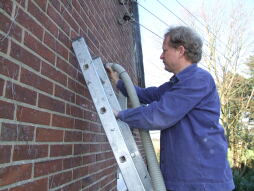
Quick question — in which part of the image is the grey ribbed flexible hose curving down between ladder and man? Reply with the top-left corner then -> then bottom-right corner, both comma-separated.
107,63 -> 166,191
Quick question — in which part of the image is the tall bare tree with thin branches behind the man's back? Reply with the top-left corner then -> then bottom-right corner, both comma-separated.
189,1 -> 254,167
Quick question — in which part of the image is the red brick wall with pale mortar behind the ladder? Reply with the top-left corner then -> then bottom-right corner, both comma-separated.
0,0 -> 140,191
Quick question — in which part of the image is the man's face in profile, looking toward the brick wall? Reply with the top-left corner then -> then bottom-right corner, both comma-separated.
160,37 -> 179,73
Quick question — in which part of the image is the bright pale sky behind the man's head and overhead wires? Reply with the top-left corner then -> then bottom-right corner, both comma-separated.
138,0 -> 254,138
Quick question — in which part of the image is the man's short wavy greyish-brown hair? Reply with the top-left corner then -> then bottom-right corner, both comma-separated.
164,26 -> 203,63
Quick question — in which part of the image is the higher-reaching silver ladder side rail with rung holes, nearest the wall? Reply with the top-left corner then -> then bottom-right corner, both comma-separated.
73,38 -> 152,191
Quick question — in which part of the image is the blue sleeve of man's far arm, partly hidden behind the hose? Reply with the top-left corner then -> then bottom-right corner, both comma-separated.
116,80 -> 159,104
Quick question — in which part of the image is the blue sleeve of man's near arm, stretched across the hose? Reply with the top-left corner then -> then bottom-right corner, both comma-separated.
118,79 -> 212,130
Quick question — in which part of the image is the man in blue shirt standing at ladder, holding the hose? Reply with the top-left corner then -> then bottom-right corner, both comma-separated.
106,26 -> 234,191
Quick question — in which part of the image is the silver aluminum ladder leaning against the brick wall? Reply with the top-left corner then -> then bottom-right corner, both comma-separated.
72,38 -> 154,191
